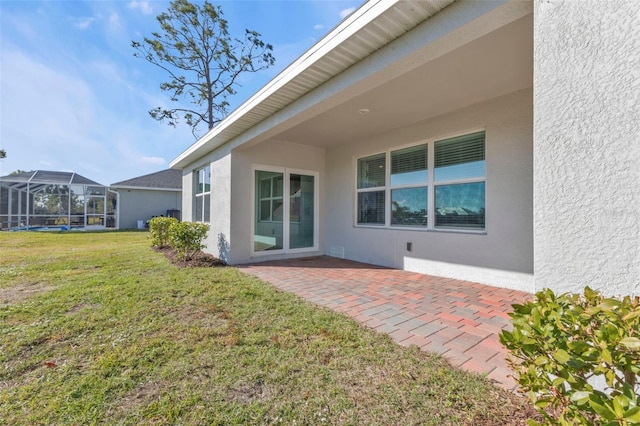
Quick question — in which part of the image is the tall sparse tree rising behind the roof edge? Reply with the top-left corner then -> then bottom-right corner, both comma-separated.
131,0 -> 275,138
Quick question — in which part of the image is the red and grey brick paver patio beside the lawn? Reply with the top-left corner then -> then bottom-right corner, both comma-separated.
240,256 -> 531,389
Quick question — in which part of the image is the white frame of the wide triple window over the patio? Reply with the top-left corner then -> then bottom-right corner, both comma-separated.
353,128 -> 487,234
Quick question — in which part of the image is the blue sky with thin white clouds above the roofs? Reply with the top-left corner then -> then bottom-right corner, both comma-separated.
0,0 -> 362,185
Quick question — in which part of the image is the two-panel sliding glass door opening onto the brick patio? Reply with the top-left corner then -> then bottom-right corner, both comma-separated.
253,168 -> 318,253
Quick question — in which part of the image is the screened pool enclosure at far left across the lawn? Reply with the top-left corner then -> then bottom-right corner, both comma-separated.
0,170 -> 117,230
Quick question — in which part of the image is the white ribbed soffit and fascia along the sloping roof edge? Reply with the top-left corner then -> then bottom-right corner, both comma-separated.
170,0 -> 455,168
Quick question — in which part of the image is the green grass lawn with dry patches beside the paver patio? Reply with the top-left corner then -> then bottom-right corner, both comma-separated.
0,232 -> 531,425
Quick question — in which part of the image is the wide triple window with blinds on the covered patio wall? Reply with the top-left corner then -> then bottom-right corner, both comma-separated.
356,131 -> 486,230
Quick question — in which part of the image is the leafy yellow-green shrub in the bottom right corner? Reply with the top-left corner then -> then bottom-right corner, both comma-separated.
500,288 -> 640,425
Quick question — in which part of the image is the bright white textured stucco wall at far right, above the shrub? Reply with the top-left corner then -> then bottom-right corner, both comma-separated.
534,0 -> 640,295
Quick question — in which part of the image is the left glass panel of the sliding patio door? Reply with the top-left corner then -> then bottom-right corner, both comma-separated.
253,170 -> 284,252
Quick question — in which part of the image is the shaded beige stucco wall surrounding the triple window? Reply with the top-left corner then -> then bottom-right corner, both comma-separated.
323,89 -> 533,291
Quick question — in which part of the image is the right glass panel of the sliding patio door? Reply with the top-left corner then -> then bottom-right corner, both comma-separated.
289,174 -> 315,249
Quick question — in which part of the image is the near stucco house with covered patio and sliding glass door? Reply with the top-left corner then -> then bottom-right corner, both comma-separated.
171,0 -> 640,294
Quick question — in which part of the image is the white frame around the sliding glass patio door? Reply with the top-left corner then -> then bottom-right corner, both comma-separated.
249,164 -> 320,257
